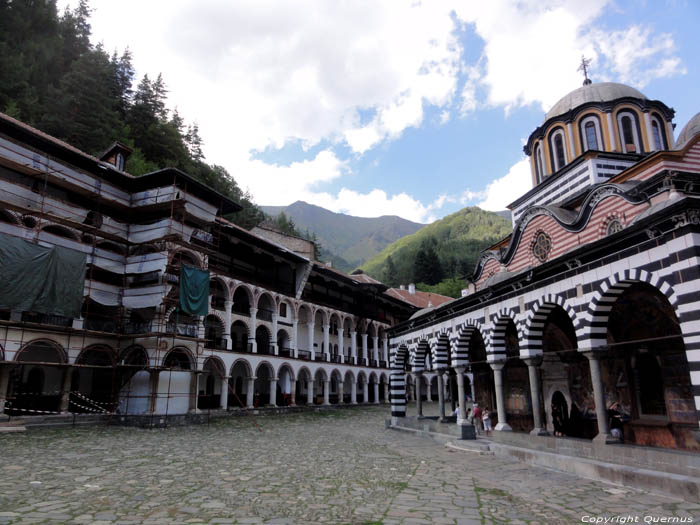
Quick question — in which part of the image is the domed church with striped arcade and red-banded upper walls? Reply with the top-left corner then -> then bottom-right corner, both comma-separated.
389,79 -> 700,450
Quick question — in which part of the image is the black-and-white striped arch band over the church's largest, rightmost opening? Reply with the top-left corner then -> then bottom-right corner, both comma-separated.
576,270 -> 678,349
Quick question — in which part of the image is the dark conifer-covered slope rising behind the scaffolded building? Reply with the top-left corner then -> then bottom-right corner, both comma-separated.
0,0 -> 264,228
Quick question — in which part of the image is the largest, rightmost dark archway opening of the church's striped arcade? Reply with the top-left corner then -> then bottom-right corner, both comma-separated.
601,283 -> 700,450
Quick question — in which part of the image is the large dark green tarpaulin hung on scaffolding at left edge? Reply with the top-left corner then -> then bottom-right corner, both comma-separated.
0,234 -> 86,317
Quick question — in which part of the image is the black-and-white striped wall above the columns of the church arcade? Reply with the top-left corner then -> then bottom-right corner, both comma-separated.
392,227 -> 700,420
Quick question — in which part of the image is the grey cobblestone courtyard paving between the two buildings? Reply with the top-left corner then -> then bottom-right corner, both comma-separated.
0,407 -> 700,524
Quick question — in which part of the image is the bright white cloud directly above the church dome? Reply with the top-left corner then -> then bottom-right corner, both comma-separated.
456,0 -> 685,113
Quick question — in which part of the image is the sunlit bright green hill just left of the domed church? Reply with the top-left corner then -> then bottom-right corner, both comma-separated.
362,207 -> 511,286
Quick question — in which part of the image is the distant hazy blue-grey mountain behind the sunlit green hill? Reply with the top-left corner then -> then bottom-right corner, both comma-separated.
261,201 -> 425,271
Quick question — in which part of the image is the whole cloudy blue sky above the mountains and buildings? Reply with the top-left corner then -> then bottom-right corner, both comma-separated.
59,0 -> 700,223
